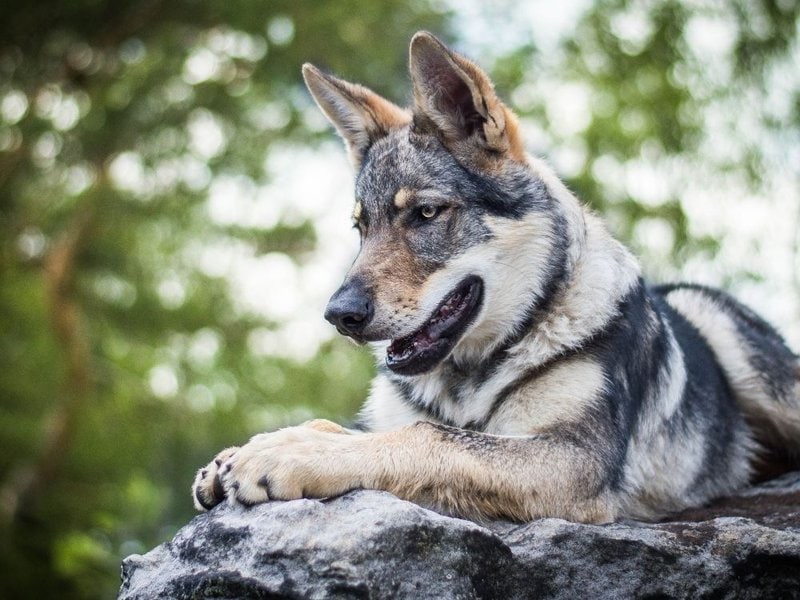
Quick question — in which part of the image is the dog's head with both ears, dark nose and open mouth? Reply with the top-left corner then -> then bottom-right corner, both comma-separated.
303,33 -> 565,375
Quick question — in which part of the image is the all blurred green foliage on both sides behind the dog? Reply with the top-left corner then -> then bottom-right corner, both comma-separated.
0,0 -> 800,598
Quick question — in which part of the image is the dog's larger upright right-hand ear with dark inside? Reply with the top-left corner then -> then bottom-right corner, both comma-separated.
409,31 -> 525,160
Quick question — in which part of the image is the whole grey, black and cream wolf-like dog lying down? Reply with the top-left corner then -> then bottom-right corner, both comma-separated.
192,32 -> 800,523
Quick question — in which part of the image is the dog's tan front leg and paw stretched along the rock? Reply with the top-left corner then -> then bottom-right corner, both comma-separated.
194,421 -> 617,522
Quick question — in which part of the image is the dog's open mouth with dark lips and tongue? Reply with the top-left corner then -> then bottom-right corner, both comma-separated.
386,275 -> 483,375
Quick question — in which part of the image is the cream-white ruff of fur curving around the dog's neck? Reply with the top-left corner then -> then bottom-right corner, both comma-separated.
373,158 -> 641,426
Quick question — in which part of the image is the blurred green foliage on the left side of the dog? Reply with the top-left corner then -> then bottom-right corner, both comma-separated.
0,0 -> 445,598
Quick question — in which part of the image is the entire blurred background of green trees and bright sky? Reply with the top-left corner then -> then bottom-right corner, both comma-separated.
0,0 -> 800,598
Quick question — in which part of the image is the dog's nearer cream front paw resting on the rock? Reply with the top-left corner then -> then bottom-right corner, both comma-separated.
208,420 -> 360,506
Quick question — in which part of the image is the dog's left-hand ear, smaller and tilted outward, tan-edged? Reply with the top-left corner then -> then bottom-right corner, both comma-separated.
303,63 -> 411,169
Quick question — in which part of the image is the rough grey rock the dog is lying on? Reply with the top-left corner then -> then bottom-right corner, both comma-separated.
120,472 -> 800,600
